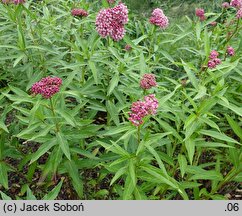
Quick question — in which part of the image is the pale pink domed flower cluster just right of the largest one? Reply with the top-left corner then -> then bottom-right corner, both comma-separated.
150,8 -> 169,29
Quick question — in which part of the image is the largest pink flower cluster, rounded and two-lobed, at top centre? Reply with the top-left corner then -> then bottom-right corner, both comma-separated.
96,2 -> 128,41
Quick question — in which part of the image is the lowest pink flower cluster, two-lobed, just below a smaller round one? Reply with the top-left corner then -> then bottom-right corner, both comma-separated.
129,94 -> 158,126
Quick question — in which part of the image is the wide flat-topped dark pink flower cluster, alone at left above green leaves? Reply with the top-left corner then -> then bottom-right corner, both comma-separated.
31,76 -> 62,99
